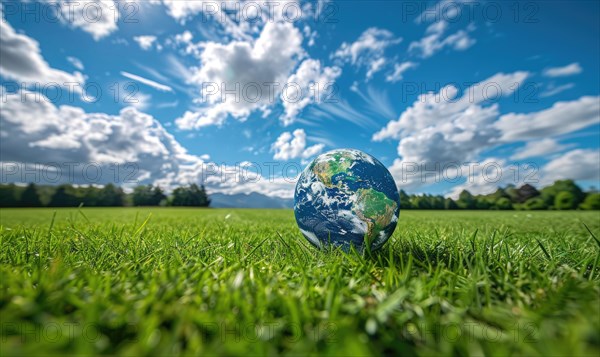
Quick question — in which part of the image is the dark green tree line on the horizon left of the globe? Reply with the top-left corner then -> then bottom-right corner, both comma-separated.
0,183 -> 210,207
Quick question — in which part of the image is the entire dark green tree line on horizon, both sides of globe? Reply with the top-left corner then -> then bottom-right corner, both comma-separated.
0,180 -> 600,210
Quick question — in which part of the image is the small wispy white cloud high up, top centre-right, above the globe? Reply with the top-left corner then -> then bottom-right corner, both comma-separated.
331,27 -> 402,79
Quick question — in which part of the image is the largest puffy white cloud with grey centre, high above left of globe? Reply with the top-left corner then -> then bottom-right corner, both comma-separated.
176,23 -> 304,129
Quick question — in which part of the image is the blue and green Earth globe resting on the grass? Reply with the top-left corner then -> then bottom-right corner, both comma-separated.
294,149 -> 400,252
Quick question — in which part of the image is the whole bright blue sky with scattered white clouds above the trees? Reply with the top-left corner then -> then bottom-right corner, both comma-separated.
0,0 -> 600,197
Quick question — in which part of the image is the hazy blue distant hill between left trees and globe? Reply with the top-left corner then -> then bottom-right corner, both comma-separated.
209,192 -> 294,208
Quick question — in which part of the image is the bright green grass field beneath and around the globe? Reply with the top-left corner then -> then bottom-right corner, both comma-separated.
0,208 -> 600,356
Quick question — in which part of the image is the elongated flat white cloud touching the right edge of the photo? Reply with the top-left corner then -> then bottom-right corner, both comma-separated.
495,96 -> 600,141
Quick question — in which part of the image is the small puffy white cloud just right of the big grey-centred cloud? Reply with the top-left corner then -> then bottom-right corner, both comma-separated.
281,59 -> 342,125
